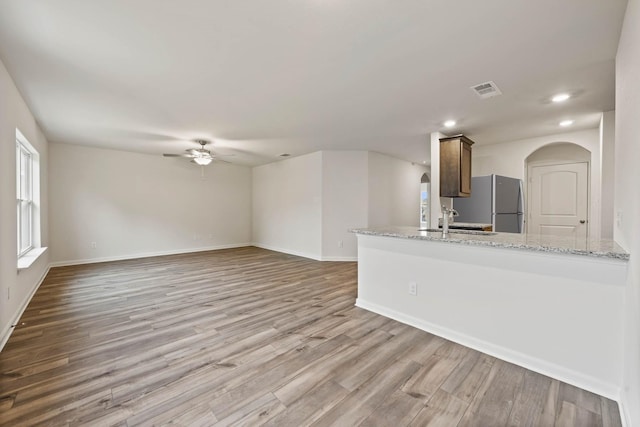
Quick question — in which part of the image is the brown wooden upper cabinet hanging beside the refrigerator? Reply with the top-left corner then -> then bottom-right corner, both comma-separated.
440,135 -> 473,197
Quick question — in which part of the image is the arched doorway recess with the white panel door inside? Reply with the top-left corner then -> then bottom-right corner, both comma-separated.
526,142 -> 591,242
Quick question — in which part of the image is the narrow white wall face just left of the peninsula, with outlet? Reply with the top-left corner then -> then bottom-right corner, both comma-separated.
322,151 -> 368,261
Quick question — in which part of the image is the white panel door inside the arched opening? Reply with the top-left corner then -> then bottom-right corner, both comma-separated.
527,162 -> 589,240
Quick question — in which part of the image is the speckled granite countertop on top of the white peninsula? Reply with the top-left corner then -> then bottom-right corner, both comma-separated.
350,226 -> 629,260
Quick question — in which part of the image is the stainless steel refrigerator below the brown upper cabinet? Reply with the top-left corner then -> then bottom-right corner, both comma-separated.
453,175 -> 524,233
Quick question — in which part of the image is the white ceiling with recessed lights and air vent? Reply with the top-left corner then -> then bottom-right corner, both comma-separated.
0,0 -> 627,165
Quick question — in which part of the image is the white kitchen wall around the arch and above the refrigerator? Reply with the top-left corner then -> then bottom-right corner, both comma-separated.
472,129 -> 602,238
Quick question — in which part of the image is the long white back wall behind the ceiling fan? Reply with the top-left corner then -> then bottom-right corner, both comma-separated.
49,144 -> 251,264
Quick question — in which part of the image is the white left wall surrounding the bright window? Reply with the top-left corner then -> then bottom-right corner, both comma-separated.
0,58 -> 49,348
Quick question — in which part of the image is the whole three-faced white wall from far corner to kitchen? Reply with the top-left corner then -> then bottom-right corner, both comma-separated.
253,151 -> 427,260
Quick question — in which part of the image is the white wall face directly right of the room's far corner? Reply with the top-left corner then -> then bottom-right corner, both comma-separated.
252,152 -> 322,260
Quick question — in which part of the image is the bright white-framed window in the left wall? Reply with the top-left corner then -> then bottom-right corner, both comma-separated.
16,139 -> 33,257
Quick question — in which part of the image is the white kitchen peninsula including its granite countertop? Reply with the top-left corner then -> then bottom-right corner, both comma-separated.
352,227 -> 629,399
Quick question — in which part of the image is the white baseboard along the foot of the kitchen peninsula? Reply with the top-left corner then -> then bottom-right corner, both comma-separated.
356,298 -> 623,407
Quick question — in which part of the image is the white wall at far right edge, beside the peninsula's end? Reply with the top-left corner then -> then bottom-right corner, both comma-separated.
614,0 -> 640,426
